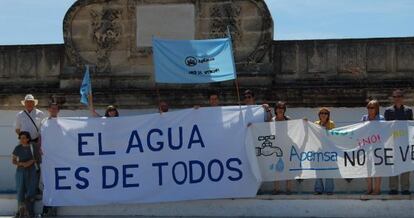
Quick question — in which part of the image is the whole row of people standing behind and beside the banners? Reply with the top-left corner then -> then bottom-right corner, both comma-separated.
12,90 -> 413,215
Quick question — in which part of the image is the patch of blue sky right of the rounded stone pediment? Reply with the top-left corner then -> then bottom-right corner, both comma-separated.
266,0 -> 414,40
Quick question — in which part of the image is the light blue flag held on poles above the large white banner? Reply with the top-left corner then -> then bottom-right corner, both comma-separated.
152,38 -> 236,83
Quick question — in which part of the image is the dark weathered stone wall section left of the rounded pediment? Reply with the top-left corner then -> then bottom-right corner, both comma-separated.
0,45 -> 65,110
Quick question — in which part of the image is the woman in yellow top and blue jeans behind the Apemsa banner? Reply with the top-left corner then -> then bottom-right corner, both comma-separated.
315,107 -> 335,195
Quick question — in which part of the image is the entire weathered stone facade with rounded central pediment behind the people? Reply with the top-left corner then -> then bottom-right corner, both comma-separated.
0,0 -> 414,110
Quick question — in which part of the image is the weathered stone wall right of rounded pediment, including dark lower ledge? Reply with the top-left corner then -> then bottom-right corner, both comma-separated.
267,38 -> 414,107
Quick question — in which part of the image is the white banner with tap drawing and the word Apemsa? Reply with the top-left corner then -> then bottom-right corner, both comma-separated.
246,120 -> 414,181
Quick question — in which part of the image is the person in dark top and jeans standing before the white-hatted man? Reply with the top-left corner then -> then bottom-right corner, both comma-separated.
12,131 -> 39,216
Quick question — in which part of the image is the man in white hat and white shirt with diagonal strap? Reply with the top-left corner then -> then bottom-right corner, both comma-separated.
15,94 -> 46,143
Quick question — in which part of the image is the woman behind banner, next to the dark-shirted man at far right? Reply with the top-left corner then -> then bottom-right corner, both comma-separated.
361,100 -> 384,195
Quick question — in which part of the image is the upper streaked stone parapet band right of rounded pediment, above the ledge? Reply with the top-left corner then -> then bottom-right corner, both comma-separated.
273,38 -> 414,81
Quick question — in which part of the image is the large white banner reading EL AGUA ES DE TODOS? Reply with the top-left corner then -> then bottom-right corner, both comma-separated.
42,106 -> 264,206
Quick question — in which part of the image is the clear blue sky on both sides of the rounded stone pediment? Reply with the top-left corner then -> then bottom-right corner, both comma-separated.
0,0 -> 414,45
